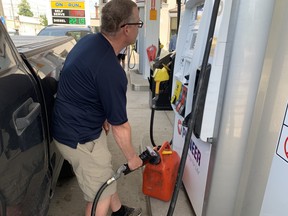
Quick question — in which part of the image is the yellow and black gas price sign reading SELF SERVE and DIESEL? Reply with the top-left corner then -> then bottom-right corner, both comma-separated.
51,1 -> 86,25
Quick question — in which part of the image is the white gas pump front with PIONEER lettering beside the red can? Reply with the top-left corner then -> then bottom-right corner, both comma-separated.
168,0 -> 213,216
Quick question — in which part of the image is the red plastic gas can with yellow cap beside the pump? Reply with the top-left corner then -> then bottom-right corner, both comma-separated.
142,141 -> 180,202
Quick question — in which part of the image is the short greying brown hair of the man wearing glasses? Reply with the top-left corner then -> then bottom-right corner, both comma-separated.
100,0 -> 137,35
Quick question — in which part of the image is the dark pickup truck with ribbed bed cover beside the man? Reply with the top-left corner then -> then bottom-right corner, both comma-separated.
0,22 -> 76,216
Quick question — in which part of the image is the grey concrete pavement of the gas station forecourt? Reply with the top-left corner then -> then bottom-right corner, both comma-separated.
48,59 -> 194,216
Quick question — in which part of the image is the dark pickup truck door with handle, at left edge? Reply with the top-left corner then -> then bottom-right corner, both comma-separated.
0,23 -> 51,216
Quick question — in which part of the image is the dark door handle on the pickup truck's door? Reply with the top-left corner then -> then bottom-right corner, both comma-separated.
13,98 -> 40,136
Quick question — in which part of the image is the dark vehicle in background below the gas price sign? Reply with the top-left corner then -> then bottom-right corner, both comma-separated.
37,25 -> 93,41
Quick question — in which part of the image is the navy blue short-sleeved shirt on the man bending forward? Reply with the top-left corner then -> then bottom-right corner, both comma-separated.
52,33 -> 128,148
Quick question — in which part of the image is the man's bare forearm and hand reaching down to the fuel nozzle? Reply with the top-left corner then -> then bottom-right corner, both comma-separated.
111,122 -> 142,170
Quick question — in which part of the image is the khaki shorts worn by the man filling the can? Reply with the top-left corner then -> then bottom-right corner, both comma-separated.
54,130 -> 117,202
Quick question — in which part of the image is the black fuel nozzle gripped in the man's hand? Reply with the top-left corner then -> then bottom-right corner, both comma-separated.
123,146 -> 161,175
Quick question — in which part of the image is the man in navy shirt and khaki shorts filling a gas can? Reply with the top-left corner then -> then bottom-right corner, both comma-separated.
53,0 -> 143,216
